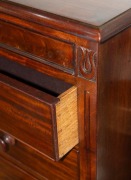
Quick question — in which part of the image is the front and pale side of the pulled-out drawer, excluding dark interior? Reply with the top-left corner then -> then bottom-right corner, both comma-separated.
0,70 -> 78,160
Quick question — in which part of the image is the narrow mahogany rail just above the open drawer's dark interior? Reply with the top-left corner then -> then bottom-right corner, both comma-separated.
0,47 -> 76,86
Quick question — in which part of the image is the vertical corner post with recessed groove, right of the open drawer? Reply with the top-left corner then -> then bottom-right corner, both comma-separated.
77,78 -> 97,180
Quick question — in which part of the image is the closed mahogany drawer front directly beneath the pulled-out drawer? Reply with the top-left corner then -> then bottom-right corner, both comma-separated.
0,131 -> 79,180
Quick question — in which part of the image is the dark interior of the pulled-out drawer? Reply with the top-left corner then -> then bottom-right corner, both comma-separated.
0,57 -> 72,97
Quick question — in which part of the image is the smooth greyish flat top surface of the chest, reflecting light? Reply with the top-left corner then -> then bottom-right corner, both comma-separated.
3,0 -> 131,26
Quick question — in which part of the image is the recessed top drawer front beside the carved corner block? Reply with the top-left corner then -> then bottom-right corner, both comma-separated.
0,21 -> 74,69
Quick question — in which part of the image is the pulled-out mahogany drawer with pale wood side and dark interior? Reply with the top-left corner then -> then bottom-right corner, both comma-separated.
0,58 -> 78,160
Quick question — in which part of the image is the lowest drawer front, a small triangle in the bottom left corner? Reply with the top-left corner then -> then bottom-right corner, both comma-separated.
0,157 -> 36,180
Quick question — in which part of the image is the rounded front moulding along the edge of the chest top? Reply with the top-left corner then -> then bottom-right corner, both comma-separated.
0,2 -> 100,41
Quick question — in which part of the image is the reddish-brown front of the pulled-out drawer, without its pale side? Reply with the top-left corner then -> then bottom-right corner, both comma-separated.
0,70 -> 74,159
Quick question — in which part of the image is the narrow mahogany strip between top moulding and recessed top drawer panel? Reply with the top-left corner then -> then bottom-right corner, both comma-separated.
0,9 -> 98,48
